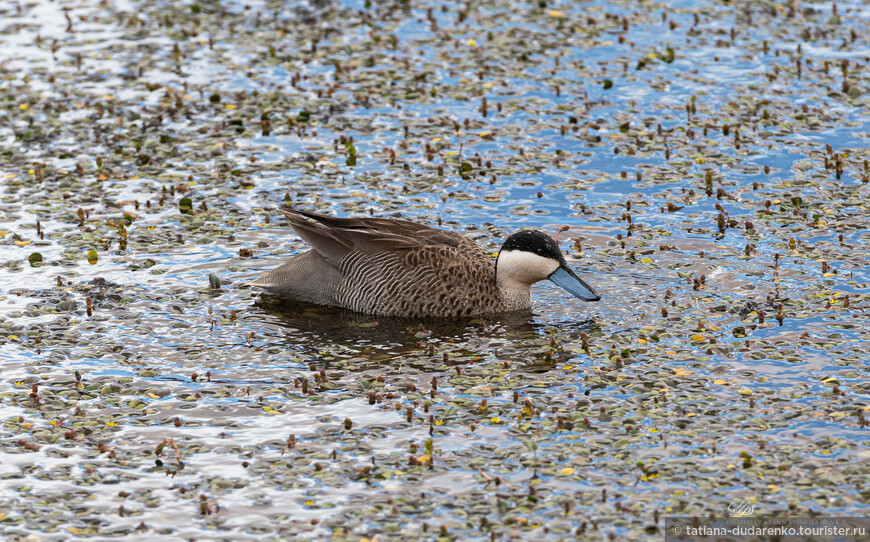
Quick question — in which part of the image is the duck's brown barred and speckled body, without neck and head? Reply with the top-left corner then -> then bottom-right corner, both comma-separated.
254,211 -> 503,317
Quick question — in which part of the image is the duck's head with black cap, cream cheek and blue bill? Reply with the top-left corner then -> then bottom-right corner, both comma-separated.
495,230 -> 601,301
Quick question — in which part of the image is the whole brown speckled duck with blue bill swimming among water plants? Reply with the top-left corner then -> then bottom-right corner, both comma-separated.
249,209 -> 601,318
